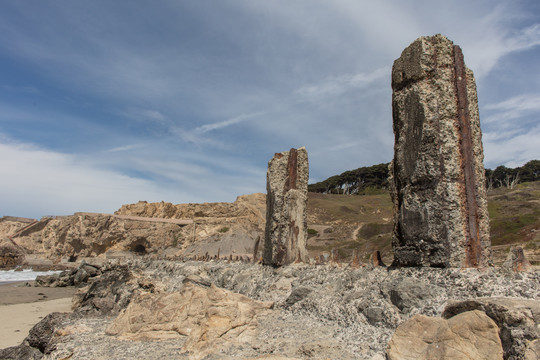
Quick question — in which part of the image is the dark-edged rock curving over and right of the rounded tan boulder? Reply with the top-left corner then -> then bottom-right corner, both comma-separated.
442,297 -> 540,360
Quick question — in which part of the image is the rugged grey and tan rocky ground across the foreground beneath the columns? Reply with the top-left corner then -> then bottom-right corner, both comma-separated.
0,260 -> 540,359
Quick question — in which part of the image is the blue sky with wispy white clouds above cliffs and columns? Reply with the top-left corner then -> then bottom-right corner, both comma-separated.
0,0 -> 540,217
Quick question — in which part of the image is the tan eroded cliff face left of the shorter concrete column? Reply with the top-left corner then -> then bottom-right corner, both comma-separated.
0,194 -> 265,265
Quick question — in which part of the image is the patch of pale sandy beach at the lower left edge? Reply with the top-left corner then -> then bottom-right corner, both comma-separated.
0,282 -> 75,349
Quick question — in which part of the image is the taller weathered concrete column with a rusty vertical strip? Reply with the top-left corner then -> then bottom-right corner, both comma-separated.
390,35 -> 491,267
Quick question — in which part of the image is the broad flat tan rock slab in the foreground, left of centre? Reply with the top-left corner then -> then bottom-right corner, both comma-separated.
107,282 -> 273,358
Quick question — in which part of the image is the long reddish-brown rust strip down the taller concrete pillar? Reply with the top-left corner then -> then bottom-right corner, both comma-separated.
454,45 -> 482,267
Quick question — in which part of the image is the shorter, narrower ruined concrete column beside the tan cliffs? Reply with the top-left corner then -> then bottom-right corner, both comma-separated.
263,147 -> 309,266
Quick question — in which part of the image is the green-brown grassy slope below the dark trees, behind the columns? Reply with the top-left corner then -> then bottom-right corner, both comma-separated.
308,182 -> 540,264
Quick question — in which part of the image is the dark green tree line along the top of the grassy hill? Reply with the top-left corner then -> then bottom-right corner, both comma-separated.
308,160 -> 540,195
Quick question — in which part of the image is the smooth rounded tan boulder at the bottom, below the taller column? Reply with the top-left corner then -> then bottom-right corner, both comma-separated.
387,310 -> 503,360
